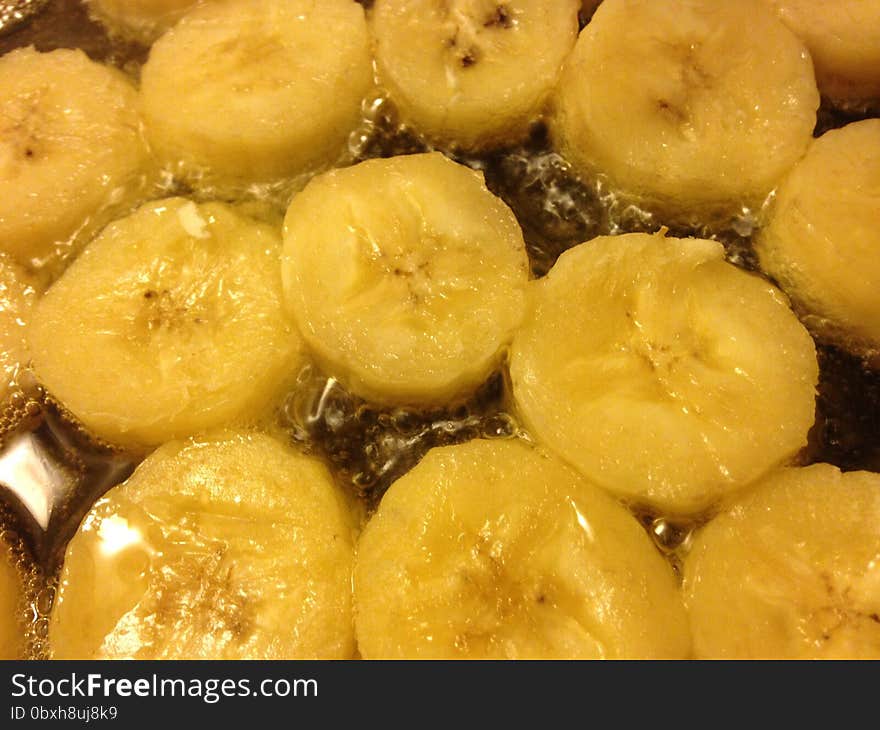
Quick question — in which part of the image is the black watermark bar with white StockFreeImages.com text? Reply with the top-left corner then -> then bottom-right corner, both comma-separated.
0,661 -> 860,730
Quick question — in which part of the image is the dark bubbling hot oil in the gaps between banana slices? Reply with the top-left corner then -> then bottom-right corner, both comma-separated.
0,0 -> 880,658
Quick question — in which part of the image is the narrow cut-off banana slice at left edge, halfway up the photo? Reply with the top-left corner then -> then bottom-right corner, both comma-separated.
0,255 -> 37,404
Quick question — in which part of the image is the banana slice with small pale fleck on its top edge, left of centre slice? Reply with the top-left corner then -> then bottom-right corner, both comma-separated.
30,198 -> 299,446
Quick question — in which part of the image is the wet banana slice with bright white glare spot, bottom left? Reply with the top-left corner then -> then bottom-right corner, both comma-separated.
49,433 -> 354,659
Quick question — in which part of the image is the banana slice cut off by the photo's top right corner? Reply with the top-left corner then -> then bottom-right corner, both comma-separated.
767,0 -> 880,107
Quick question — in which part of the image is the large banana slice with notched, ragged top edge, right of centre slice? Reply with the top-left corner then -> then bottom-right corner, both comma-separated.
510,232 -> 818,514
